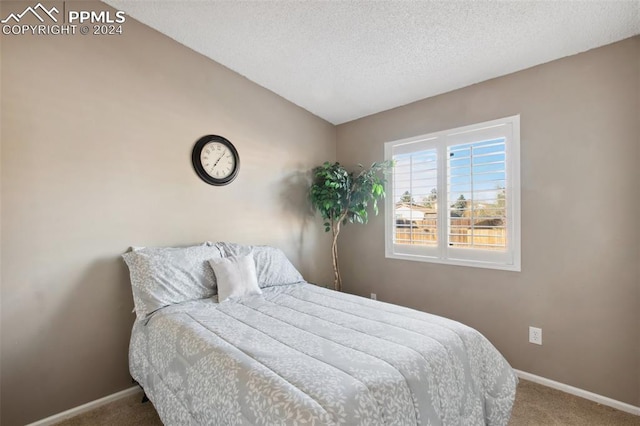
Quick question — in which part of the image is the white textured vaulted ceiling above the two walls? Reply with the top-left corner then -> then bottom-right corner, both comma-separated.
105,0 -> 640,124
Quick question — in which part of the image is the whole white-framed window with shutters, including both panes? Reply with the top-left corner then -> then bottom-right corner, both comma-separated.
384,116 -> 520,271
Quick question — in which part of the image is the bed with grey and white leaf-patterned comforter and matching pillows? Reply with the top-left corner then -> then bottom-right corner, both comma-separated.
125,243 -> 517,425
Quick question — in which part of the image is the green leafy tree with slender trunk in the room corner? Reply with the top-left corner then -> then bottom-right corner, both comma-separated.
310,161 -> 393,291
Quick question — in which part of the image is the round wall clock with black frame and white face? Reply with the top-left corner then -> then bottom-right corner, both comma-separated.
191,135 -> 240,185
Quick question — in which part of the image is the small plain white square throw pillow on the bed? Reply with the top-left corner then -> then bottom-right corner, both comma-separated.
209,254 -> 262,303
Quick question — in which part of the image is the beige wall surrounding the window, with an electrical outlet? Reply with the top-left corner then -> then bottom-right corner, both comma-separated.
337,37 -> 640,405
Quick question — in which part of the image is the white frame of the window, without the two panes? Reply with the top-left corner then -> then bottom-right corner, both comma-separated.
384,115 -> 521,271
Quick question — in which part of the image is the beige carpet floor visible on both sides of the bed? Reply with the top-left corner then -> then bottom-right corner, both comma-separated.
57,380 -> 640,426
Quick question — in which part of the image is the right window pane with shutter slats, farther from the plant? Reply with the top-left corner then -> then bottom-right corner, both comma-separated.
447,138 -> 507,250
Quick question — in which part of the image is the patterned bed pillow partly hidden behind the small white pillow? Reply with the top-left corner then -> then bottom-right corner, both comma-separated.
216,242 -> 304,288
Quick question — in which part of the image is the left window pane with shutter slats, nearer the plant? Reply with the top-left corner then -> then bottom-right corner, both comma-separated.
392,149 -> 438,246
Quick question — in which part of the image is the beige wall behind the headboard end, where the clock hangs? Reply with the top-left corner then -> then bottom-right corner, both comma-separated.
0,2 -> 335,426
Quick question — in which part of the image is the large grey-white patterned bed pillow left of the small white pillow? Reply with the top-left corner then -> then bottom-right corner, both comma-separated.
122,244 -> 222,320
